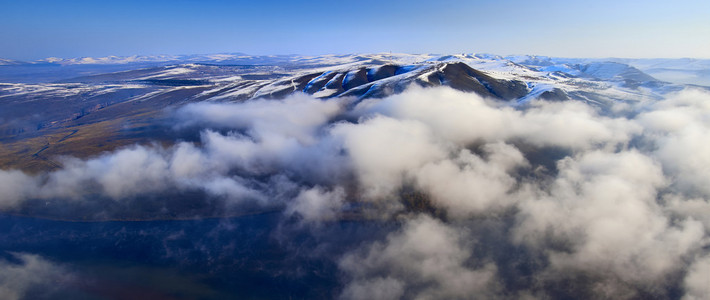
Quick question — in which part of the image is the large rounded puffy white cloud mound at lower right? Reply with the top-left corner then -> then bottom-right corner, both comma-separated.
516,151 -> 704,292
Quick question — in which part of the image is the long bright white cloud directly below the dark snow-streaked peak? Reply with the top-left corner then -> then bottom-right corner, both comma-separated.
354,87 -> 640,149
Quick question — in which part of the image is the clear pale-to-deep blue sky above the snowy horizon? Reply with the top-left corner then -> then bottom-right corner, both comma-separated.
0,0 -> 710,60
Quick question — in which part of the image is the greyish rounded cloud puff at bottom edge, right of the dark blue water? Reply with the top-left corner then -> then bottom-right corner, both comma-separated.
340,216 -> 496,299
